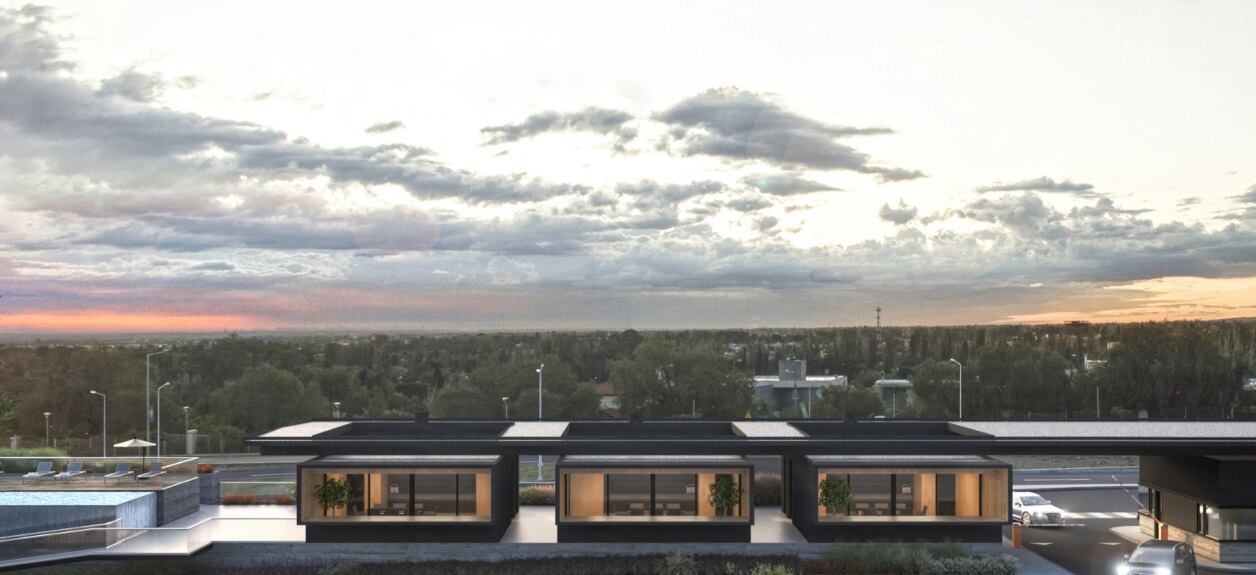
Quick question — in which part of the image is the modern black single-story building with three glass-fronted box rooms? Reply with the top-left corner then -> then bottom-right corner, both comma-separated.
247,419 -> 1256,560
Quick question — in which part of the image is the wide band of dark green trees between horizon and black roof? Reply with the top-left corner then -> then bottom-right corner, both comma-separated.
0,321 -> 1256,437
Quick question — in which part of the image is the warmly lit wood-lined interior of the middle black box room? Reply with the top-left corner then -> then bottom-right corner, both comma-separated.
559,468 -> 751,522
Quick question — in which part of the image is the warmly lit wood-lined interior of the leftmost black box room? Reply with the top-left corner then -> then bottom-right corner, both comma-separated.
300,468 -> 492,522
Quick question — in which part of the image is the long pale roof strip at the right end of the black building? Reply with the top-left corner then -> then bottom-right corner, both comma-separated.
951,421 -> 1256,439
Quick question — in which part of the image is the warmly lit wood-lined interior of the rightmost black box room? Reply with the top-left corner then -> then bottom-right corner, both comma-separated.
816,468 -> 1010,522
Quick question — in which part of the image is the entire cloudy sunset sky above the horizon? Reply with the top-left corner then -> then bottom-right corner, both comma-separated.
0,0 -> 1256,334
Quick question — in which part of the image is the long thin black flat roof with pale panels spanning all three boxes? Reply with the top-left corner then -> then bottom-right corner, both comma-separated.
246,419 -> 1256,456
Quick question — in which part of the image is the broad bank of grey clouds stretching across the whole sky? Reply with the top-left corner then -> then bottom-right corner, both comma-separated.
0,4 -> 1256,330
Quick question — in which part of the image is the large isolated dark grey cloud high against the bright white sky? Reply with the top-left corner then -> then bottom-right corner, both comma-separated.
654,88 -> 924,182
